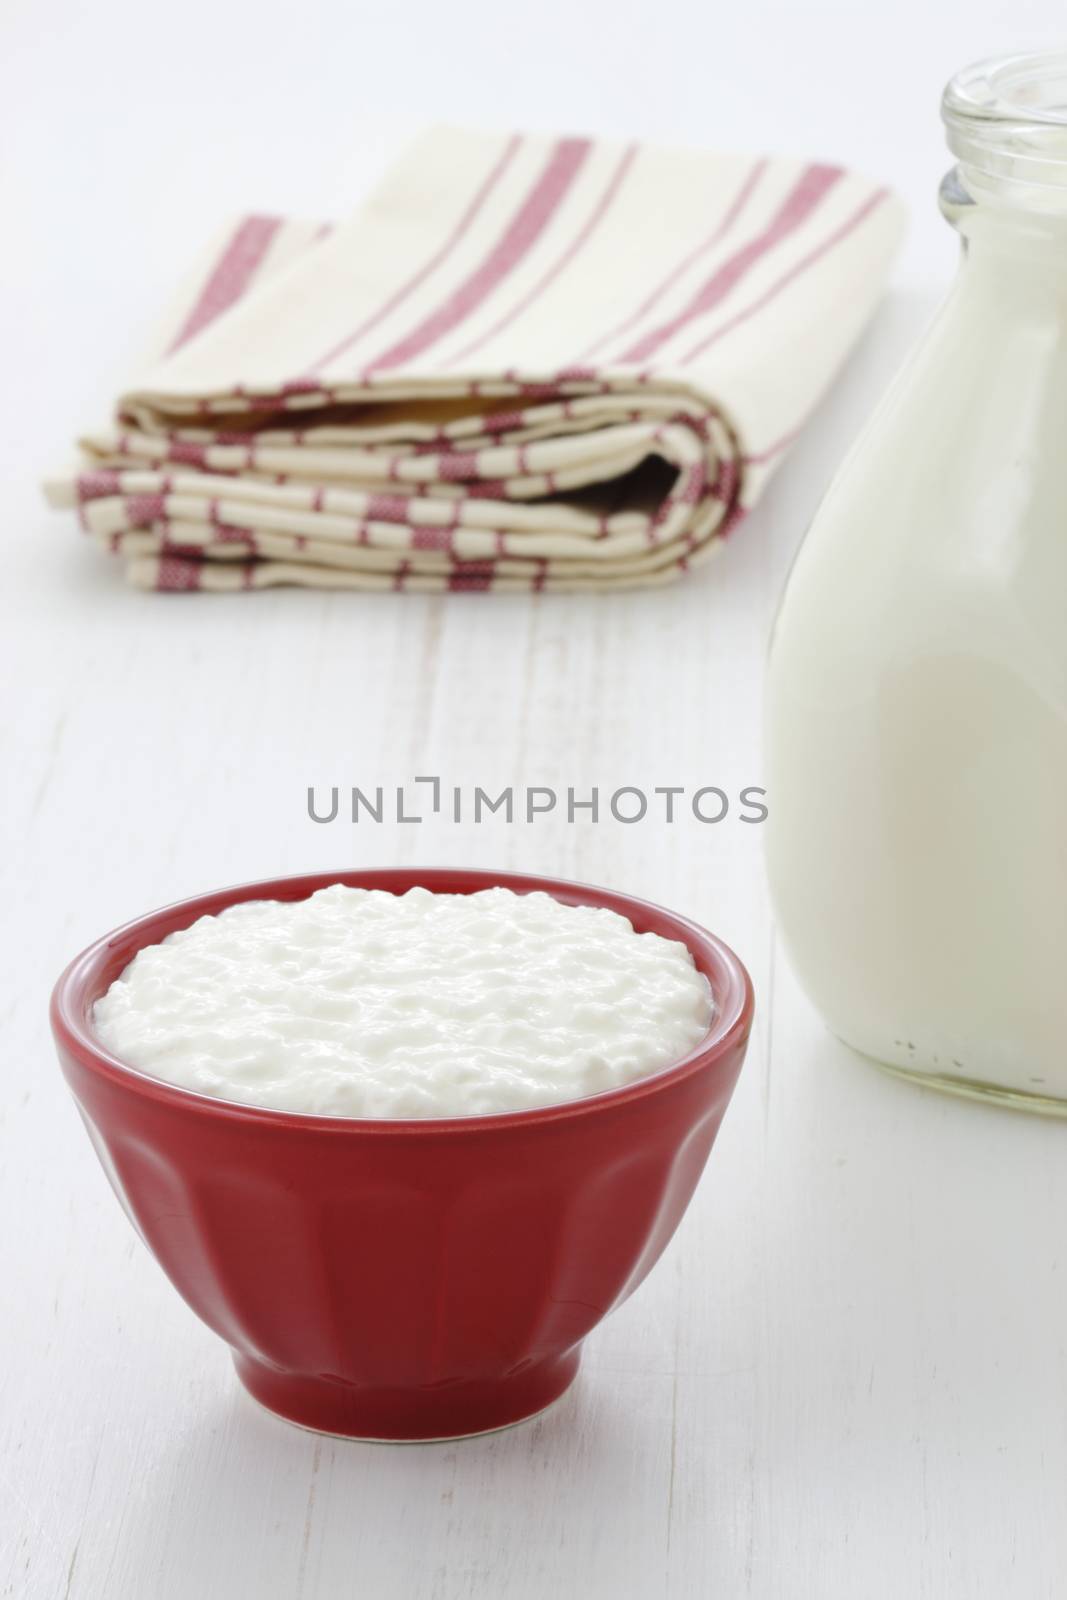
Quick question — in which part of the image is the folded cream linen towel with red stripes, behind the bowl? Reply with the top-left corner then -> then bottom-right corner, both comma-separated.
46,130 -> 902,590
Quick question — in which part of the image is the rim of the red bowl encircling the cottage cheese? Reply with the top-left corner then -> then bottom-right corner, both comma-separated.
50,867 -> 755,1138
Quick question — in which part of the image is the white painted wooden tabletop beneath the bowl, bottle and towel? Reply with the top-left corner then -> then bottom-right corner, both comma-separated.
0,0 -> 1067,1600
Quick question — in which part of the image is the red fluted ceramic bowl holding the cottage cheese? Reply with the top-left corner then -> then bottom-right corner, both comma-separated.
51,869 -> 752,1438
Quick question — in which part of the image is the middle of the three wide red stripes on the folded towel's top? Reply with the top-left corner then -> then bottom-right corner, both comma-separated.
365,139 -> 590,374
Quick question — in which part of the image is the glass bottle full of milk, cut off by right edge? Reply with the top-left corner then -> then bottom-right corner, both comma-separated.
766,56 -> 1067,1114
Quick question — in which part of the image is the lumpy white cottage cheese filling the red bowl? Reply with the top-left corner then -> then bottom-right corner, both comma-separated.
94,883 -> 713,1117
